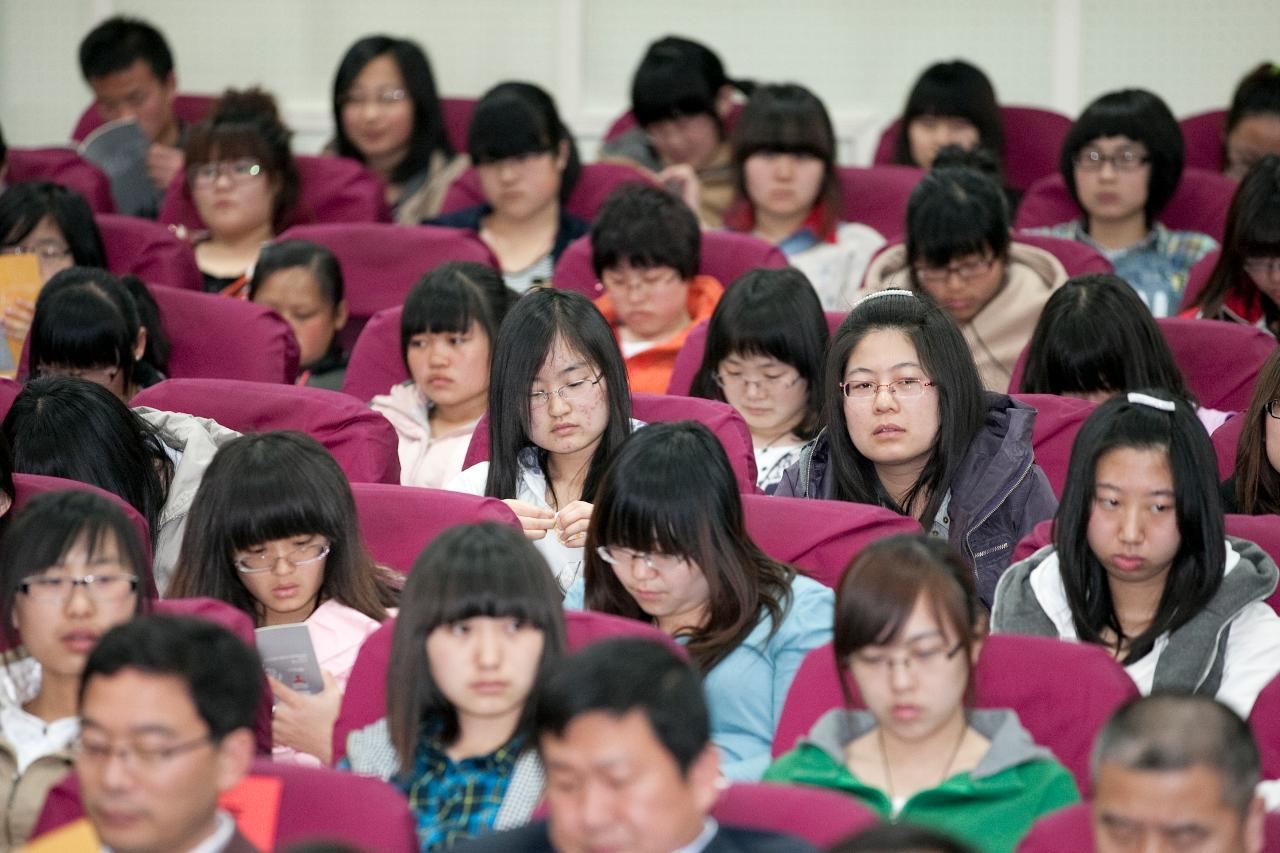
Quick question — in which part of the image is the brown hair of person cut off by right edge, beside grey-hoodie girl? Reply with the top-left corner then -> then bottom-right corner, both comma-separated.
1222,350 -> 1280,515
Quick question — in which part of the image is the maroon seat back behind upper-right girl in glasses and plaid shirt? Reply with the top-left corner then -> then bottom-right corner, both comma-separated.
1014,169 -> 1235,242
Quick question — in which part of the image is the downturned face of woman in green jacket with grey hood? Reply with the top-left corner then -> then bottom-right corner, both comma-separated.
847,594 -> 980,742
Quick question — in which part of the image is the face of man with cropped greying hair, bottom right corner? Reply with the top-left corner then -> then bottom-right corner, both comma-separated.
1093,762 -> 1266,853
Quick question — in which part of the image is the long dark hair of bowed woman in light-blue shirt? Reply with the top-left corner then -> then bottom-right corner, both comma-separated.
585,420 -> 795,675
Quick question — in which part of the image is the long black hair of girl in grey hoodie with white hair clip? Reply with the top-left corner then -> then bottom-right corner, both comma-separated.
1053,391 -> 1226,665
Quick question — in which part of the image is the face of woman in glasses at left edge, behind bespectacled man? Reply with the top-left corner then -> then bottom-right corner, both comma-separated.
13,532 -> 138,679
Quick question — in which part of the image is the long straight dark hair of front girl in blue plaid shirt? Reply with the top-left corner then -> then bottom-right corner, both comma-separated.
387,521 -> 566,774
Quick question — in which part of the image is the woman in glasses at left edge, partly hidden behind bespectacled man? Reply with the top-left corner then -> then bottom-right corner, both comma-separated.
0,491 -> 151,849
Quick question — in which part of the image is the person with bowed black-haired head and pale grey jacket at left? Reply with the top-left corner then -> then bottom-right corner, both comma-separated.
4,377 -> 239,594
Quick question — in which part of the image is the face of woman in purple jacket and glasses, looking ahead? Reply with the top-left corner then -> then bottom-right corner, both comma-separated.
844,329 -> 941,473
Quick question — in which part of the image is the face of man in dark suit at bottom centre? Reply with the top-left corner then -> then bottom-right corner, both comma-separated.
540,711 -> 719,853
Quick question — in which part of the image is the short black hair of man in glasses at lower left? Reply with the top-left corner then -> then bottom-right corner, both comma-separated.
79,615 -> 266,743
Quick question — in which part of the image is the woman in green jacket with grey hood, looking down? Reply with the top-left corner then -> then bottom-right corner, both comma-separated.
764,533 -> 1079,853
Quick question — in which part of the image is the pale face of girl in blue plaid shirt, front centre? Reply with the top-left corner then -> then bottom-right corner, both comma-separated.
426,616 -> 545,725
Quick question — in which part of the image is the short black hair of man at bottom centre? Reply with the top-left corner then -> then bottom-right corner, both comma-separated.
534,638 -> 712,774
